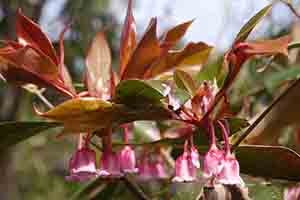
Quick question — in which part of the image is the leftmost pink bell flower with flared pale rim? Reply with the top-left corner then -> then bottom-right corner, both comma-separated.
66,147 -> 97,181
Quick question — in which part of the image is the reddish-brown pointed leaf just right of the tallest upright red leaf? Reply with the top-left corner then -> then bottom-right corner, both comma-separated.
121,18 -> 161,80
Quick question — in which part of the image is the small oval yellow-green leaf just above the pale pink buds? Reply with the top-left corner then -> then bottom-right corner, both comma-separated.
174,69 -> 197,96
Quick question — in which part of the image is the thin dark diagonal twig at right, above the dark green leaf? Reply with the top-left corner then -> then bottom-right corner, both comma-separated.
231,79 -> 300,151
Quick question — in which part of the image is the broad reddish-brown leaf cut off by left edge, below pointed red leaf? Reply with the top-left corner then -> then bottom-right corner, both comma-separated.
0,42 -> 74,96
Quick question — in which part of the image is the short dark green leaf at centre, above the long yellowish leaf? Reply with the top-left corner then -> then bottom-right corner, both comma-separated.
115,79 -> 170,106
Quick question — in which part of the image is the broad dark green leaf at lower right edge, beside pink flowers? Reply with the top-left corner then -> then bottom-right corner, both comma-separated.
236,145 -> 300,181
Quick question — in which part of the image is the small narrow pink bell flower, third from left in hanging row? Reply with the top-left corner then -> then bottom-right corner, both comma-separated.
119,145 -> 138,173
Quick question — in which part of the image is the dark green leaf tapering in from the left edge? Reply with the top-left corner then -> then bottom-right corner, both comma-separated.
0,122 -> 61,150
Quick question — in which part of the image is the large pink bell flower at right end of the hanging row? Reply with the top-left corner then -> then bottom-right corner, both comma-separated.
217,153 -> 245,186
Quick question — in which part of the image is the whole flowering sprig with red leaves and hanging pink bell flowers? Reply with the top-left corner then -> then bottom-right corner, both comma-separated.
0,0 -> 290,192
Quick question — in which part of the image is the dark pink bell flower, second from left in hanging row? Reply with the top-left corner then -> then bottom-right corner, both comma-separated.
99,150 -> 122,176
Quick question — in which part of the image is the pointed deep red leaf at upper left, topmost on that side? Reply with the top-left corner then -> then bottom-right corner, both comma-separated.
16,9 -> 59,65
